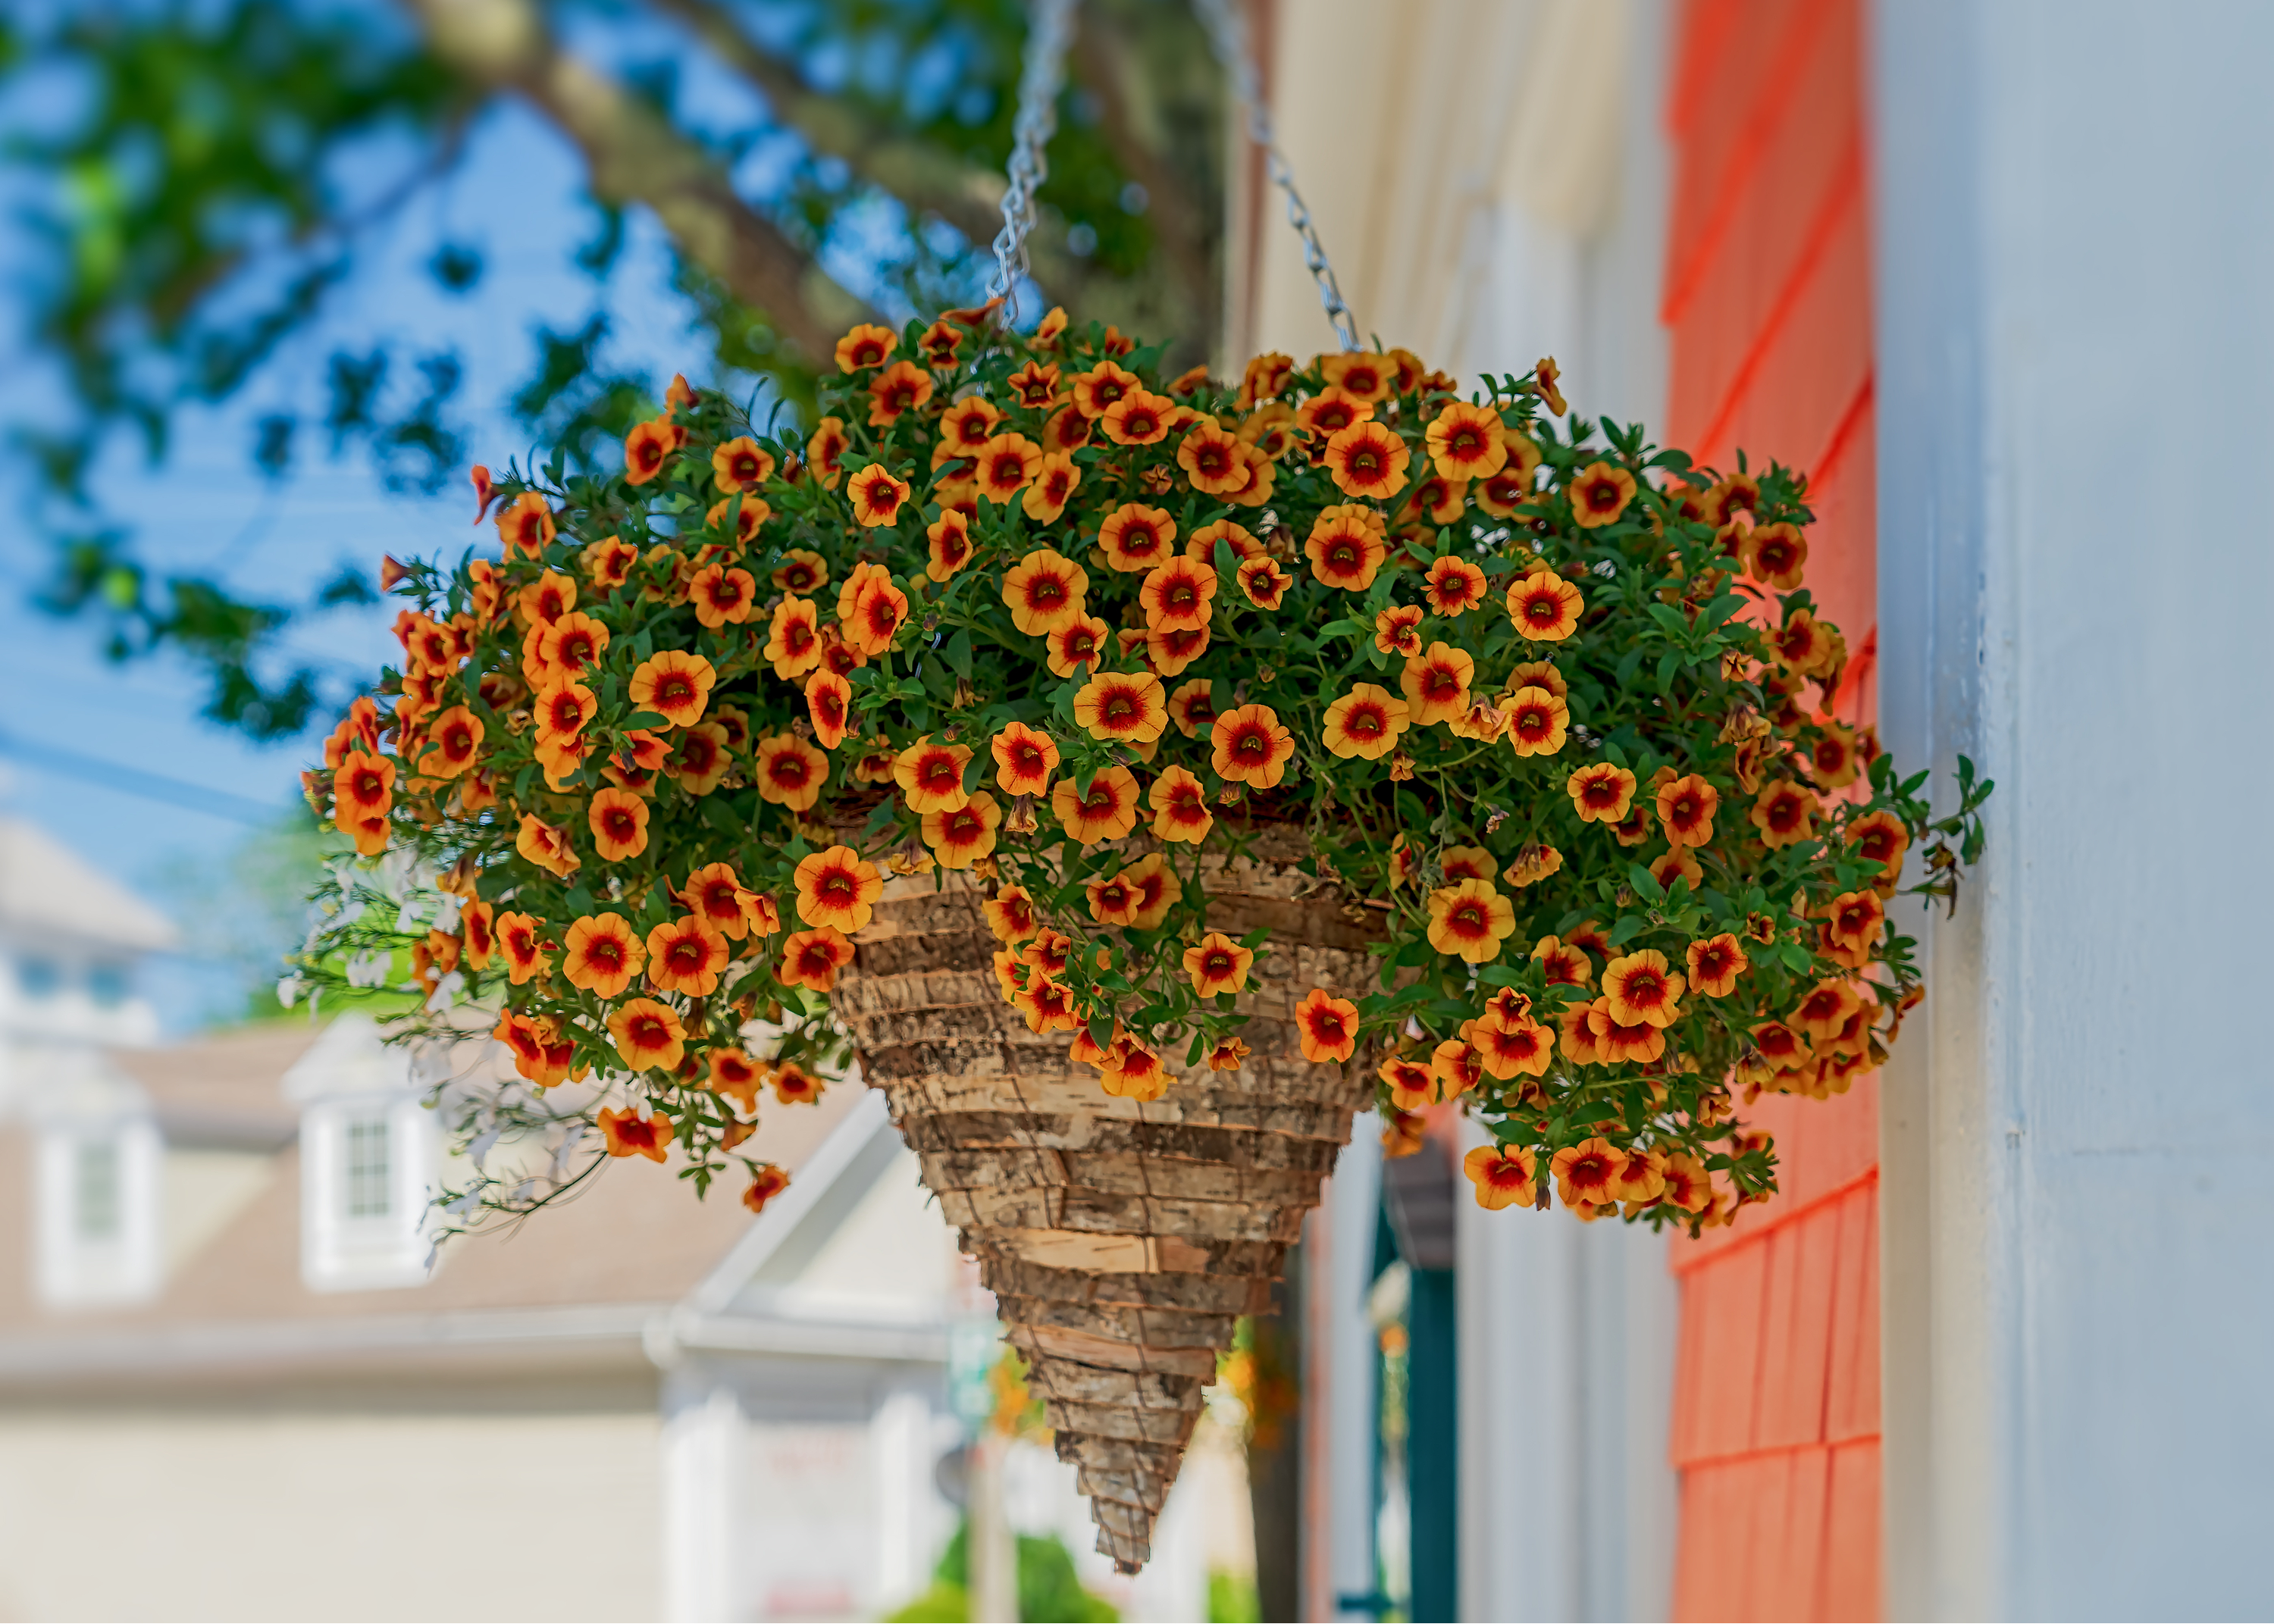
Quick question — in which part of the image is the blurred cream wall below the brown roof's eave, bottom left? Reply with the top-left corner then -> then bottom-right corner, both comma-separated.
0,1408 -> 664,1619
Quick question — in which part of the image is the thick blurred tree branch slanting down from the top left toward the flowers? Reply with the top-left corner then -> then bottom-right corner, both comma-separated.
409,0 -> 860,364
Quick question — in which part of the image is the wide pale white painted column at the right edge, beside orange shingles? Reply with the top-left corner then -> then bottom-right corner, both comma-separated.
1872,0 -> 2274,1617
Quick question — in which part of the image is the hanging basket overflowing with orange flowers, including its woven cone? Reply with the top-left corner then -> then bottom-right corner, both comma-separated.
302,309 -> 1987,1565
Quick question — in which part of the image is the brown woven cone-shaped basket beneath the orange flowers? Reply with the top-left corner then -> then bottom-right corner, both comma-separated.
835,831 -> 1373,1572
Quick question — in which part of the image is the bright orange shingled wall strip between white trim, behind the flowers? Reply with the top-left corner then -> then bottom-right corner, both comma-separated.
1662,0 -> 1881,1619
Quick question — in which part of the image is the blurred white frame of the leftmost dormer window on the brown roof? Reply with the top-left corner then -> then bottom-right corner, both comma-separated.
32,1115 -> 164,1308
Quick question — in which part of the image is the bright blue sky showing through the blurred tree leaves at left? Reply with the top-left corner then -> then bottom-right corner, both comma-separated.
0,107 -> 728,1031
